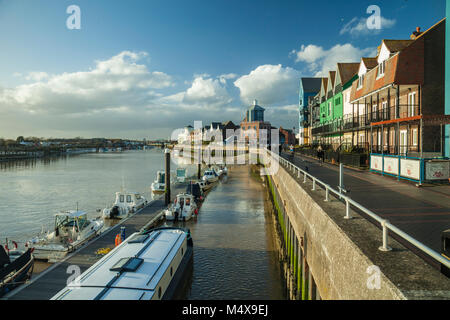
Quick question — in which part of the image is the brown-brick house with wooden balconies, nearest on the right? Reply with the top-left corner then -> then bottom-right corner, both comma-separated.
351,20 -> 445,158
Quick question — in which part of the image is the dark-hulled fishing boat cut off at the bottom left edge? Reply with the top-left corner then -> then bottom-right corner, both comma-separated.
0,242 -> 34,297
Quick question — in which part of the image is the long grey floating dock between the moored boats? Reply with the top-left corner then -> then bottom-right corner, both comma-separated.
2,184 -> 187,300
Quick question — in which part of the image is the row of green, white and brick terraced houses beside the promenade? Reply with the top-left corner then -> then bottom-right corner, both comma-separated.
309,19 -> 450,183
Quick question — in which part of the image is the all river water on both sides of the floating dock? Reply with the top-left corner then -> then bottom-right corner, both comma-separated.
0,149 -> 286,300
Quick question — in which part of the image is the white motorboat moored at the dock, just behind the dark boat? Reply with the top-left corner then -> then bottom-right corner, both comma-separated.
28,211 -> 104,262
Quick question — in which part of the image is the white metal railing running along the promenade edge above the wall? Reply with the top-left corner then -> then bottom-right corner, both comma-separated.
266,150 -> 450,268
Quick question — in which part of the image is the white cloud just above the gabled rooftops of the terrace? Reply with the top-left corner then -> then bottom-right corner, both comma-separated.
291,43 -> 376,77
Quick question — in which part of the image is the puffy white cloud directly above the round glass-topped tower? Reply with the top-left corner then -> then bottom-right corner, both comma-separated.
234,64 -> 300,105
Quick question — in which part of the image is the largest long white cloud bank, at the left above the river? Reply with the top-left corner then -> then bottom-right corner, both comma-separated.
0,51 -> 173,114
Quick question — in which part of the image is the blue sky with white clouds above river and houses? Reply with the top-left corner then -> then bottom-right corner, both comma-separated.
0,0 -> 445,139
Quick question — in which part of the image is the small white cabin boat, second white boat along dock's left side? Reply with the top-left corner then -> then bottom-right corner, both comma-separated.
102,191 -> 147,219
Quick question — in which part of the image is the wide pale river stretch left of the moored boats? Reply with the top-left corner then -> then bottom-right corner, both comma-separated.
0,149 -> 183,242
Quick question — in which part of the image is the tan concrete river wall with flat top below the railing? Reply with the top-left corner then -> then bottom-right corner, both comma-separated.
269,158 -> 450,300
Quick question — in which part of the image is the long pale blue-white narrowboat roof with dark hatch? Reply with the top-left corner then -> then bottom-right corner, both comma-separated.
52,229 -> 187,300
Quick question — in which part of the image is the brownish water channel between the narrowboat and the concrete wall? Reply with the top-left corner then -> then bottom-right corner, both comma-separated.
167,167 -> 286,300
